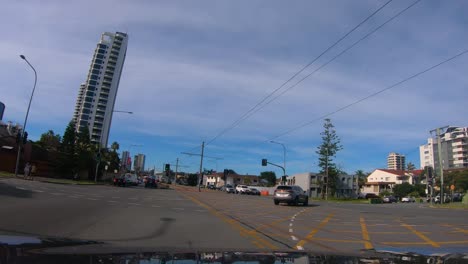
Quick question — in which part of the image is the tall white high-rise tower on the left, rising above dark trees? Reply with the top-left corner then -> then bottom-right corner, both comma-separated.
73,32 -> 128,147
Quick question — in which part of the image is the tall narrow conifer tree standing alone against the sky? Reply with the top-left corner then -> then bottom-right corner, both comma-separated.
316,118 -> 343,196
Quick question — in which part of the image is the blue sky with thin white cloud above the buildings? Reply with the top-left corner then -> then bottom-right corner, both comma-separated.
0,0 -> 468,175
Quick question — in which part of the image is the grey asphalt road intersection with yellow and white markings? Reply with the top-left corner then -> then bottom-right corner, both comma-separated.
0,176 -> 468,254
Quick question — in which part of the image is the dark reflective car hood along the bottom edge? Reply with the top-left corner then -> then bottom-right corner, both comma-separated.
0,235 -> 468,264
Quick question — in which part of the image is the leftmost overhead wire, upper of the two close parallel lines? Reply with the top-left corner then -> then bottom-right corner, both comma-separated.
206,0 -> 394,145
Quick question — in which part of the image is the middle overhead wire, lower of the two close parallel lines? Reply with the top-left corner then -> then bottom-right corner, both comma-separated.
221,0 -> 421,132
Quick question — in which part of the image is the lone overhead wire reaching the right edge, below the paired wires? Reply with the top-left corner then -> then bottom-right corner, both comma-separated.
266,49 -> 468,141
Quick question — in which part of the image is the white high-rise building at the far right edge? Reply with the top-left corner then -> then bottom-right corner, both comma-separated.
419,127 -> 468,174
